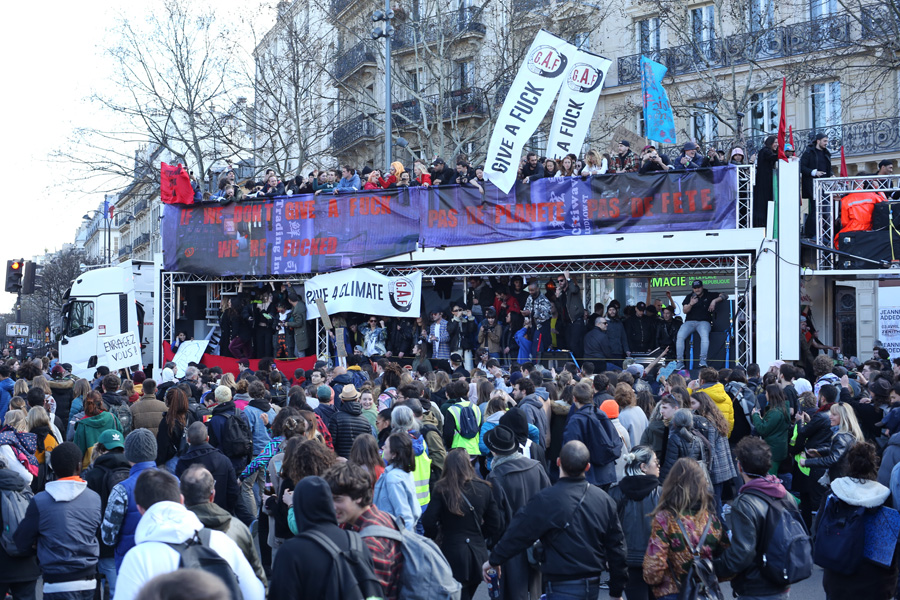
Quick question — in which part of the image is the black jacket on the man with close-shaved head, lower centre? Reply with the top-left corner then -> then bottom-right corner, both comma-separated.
490,477 -> 628,597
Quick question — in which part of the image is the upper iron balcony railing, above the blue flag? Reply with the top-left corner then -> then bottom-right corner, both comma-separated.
618,15 -> 852,85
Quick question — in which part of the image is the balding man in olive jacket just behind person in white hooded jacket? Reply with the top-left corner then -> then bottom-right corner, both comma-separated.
179,464 -> 266,583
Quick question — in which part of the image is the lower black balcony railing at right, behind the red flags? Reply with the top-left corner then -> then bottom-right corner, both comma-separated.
659,117 -> 900,161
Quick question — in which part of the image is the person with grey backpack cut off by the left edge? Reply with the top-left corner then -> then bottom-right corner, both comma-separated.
0,460 -> 41,600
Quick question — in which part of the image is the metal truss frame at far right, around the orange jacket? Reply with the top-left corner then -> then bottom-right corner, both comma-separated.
813,175 -> 900,271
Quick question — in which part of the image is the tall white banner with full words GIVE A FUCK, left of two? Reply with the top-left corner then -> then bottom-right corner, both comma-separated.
484,30 -> 576,194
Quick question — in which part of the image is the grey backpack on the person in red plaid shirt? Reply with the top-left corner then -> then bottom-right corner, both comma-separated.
359,517 -> 462,600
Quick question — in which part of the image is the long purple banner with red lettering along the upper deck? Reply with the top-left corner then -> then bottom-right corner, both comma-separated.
162,167 -> 737,275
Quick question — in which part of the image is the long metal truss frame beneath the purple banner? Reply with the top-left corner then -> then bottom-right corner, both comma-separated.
161,252 -> 756,365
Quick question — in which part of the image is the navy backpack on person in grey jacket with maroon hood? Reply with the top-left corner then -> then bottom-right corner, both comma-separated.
746,491 -> 813,587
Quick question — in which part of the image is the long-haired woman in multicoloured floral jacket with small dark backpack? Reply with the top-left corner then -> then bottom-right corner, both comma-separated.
643,458 -> 729,600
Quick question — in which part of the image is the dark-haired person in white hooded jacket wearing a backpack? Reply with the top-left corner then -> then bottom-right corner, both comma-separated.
110,468 -> 266,600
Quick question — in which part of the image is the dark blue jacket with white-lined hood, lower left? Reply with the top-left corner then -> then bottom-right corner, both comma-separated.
13,479 -> 103,583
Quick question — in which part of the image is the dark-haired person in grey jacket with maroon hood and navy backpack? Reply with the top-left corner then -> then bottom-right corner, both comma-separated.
713,437 -> 812,600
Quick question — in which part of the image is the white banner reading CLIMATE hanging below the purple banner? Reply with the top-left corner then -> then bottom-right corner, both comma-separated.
303,269 -> 422,319
